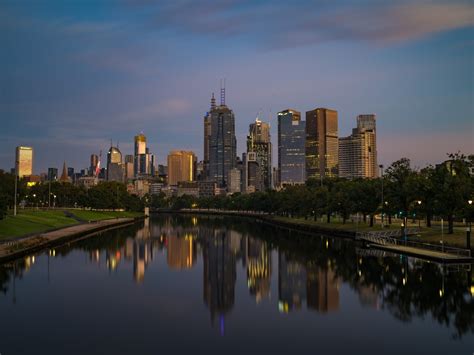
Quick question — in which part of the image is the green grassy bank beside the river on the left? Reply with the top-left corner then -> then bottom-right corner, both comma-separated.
0,210 -> 143,239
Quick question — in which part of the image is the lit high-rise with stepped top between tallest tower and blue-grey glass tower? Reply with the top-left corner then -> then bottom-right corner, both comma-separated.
247,117 -> 272,189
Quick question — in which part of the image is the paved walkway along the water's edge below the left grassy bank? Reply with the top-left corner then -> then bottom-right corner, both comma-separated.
0,218 -> 134,261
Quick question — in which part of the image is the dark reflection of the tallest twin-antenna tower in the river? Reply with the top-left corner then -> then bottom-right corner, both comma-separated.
201,228 -> 240,335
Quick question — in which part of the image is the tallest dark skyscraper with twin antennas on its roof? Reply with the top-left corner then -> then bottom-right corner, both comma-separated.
209,92 -> 237,187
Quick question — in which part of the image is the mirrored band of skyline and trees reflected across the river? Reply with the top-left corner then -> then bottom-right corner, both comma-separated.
0,217 -> 474,338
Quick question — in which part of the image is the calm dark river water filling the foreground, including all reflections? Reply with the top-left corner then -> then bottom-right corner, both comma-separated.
0,216 -> 474,355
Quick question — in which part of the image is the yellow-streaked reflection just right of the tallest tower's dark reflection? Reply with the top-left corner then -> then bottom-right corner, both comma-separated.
246,237 -> 272,303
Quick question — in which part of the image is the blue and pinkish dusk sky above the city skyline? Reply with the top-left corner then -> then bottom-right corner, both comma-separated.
0,0 -> 474,174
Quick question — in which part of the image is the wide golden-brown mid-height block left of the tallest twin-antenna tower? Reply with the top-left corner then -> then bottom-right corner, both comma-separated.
168,150 -> 197,186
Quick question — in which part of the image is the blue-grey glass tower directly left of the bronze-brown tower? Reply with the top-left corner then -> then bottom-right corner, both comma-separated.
278,109 -> 305,186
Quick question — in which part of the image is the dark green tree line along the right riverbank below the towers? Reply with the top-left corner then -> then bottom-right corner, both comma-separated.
151,153 -> 474,234
